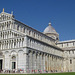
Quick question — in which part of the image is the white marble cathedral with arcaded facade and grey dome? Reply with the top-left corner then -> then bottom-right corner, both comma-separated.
0,9 -> 75,73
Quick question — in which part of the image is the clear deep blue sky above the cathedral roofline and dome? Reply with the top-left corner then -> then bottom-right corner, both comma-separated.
0,0 -> 75,41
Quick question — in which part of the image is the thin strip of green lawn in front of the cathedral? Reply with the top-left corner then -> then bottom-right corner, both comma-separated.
0,72 -> 75,75
